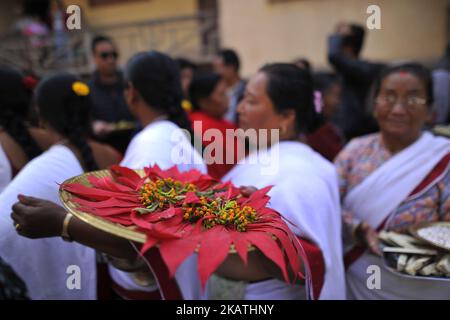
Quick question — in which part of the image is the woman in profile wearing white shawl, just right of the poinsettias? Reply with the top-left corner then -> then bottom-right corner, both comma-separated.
208,64 -> 345,299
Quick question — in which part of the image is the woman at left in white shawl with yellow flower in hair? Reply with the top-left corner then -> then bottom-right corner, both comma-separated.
0,74 -> 119,299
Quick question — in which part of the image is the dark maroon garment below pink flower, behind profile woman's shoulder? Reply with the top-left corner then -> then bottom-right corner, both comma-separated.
306,122 -> 344,161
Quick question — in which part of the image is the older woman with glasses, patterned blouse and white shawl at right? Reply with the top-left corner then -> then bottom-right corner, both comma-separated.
335,64 -> 450,300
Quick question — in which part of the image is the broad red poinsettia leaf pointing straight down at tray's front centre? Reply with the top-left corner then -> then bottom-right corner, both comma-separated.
198,226 -> 231,288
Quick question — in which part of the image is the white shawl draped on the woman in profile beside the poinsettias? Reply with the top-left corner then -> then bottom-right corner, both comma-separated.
214,142 -> 345,300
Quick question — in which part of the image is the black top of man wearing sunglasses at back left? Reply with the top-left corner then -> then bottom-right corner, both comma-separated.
88,72 -> 134,123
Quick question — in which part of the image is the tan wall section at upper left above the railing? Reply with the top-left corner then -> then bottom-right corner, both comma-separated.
64,0 -> 200,65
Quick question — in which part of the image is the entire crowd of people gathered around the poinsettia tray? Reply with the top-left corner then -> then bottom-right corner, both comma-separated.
0,23 -> 450,300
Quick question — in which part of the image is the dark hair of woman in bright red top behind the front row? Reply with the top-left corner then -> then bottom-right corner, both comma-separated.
189,73 -> 221,110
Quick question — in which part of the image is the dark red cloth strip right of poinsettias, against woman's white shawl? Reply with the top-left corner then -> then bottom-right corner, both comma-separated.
298,238 -> 325,300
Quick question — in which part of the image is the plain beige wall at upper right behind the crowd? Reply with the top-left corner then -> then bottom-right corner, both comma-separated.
219,0 -> 449,76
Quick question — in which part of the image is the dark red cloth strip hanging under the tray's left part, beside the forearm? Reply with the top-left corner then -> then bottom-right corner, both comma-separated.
144,247 -> 183,300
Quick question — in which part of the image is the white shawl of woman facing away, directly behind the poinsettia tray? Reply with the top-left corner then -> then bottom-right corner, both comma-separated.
109,120 -> 206,300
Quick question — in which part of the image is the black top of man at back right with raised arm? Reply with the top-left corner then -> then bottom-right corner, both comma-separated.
328,34 -> 385,140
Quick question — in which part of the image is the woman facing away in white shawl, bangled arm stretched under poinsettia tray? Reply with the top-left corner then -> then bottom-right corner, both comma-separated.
7,52 -> 206,299
